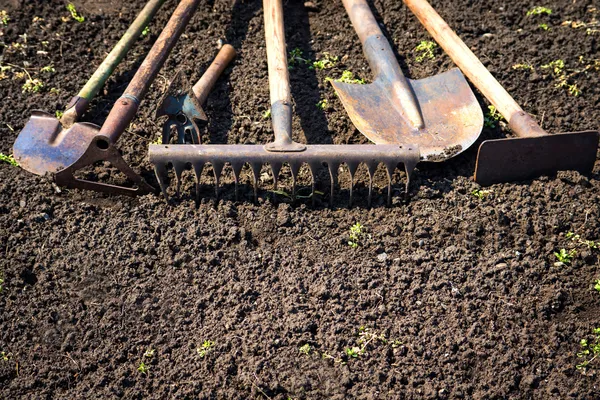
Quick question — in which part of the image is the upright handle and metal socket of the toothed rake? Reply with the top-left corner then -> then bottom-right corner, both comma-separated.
263,0 -> 306,151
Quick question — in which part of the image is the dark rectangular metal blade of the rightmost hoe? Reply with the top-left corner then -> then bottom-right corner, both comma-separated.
475,131 -> 598,186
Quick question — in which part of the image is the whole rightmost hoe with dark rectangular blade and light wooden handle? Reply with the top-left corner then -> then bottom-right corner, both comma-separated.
404,0 -> 598,185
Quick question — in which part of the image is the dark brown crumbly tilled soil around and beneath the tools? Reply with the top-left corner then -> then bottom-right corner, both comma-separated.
0,0 -> 600,399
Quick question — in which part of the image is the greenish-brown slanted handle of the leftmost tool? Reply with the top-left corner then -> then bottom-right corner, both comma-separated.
60,0 -> 165,128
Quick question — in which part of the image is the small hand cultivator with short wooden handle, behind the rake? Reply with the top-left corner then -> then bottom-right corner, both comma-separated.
156,44 -> 235,144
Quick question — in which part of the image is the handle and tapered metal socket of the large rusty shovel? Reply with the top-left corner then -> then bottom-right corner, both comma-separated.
342,0 -> 425,129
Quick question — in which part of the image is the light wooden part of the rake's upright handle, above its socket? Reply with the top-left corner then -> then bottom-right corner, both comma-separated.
263,0 -> 292,105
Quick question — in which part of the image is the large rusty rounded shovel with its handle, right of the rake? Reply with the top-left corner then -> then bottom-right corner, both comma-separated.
331,0 -> 483,161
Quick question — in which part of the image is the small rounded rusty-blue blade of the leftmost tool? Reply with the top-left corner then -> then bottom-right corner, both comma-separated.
13,111 -> 98,175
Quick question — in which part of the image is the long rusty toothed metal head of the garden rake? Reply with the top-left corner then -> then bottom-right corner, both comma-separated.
149,144 -> 420,206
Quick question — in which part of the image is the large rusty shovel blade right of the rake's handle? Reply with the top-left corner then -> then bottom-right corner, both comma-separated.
332,68 -> 483,161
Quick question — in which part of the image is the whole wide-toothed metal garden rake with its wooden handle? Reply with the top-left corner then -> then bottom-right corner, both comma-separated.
148,0 -> 419,205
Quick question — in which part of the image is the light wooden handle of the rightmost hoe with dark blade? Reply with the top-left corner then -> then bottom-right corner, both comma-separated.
404,0 -> 547,137
